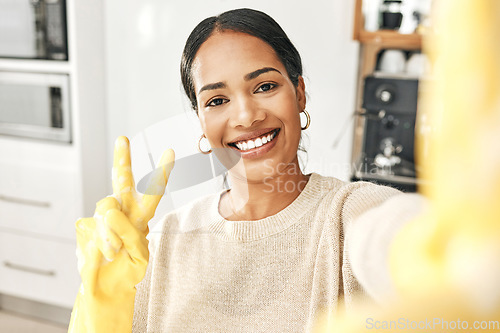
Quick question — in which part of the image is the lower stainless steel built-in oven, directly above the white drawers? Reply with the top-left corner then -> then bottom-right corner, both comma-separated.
0,72 -> 71,142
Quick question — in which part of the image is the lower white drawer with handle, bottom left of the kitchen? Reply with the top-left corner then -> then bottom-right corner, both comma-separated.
0,232 -> 80,308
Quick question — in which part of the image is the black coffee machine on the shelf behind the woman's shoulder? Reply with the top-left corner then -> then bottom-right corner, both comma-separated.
352,75 -> 418,192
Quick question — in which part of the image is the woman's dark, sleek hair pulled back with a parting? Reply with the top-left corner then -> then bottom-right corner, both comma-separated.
181,8 -> 302,113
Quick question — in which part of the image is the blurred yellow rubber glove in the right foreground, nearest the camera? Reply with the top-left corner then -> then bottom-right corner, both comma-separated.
320,0 -> 500,333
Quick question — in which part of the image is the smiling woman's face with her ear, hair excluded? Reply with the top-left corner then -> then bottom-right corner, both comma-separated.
192,31 -> 305,182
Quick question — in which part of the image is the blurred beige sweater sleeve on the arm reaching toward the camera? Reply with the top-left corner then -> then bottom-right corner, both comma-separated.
345,187 -> 425,304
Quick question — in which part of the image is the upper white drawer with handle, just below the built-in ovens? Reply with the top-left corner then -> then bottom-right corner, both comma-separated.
0,162 -> 80,239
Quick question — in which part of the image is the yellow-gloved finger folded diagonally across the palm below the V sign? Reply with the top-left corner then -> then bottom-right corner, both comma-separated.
104,209 -> 149,265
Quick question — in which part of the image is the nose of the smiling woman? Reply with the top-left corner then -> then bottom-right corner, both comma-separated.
229,97 -> 266,128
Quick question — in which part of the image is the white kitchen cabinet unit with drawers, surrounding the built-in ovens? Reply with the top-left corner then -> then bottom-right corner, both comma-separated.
0,0 -> 110,318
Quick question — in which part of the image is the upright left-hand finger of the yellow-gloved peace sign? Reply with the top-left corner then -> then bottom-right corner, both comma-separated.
112,136 -> 135,204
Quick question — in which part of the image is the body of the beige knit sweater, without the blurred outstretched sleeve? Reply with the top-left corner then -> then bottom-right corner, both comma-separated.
133,173 -> 418,333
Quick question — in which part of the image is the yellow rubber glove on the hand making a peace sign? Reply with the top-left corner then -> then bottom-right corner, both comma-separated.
68,137 -> 174,333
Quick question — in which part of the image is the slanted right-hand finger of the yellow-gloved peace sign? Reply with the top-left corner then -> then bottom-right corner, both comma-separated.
142,149 -> 175,213
